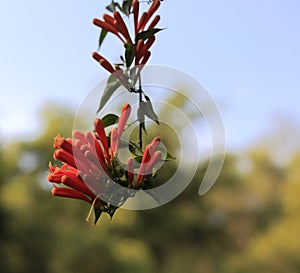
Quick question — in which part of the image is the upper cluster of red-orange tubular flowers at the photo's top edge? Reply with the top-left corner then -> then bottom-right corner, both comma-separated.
92,0 -> 161,73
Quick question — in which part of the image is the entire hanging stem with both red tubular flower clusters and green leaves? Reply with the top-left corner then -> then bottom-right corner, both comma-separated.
48,0 -> 171,223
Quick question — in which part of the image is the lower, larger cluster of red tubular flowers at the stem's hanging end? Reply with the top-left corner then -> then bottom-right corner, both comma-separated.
48,104 -> 162,223
